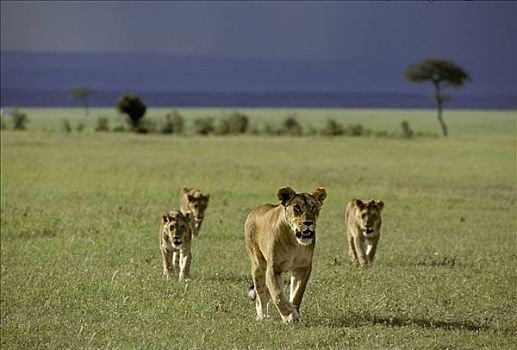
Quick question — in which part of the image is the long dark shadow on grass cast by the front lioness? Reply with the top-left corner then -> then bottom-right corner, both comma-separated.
313,313 -> 511,333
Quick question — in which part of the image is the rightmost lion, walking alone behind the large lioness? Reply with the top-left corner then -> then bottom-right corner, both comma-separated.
345,199 -> 384,266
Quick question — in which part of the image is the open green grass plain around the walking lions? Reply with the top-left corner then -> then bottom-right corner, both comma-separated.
0,109 -> 517,349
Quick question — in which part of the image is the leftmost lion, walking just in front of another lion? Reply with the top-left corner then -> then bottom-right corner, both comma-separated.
160,210 -> 192,280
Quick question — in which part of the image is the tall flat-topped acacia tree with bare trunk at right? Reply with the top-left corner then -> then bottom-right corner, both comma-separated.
405,59 -> 470,137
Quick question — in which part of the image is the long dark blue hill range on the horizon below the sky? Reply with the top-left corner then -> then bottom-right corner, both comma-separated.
1,52 -> 517,109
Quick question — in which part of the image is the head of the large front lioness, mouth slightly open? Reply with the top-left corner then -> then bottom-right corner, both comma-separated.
277,187 -> 327,245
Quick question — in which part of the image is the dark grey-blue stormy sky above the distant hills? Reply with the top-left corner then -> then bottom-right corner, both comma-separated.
1,1 -> 517,94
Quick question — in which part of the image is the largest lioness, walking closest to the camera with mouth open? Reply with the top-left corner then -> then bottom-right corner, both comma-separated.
244,187 -> 327,323
